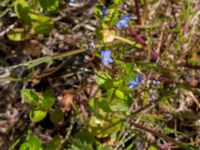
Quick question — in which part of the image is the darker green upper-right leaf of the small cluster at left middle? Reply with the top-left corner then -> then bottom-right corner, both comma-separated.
40,90 -> 55,110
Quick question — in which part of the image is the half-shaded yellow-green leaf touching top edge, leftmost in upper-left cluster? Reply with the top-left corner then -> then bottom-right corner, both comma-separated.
14,0 -> 31,25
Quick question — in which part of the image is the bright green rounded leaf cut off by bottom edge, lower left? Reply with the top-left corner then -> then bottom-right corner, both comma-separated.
20,135 -> 42,150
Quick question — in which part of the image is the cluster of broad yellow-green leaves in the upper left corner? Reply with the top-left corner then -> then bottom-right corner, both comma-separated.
7,0 -> 60,41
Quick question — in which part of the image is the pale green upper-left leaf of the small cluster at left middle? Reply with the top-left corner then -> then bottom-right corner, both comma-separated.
21,89 -> 39,106
